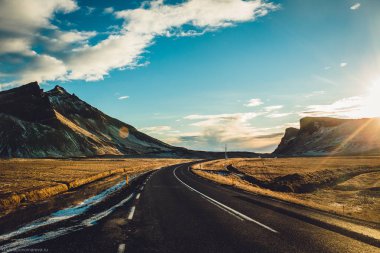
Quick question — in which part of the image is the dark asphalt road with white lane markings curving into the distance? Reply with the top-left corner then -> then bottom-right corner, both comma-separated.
3,165 -> 380,253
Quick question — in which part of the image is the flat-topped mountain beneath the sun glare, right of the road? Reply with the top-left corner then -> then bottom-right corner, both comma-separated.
273,117 -> 380,156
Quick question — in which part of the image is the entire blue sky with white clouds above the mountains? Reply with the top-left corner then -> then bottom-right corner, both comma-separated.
0,0 -> 380,152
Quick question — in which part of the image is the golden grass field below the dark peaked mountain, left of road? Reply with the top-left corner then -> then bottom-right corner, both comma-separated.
0,159 -> 187,217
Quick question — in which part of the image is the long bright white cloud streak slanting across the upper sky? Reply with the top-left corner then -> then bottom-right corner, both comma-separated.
68,0 -> 275,81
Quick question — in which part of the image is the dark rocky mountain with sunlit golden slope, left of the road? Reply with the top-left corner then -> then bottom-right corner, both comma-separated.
0,82 -> 190,157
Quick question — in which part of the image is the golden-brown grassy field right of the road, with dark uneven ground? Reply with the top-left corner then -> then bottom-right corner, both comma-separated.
192,157 -> 380,223
